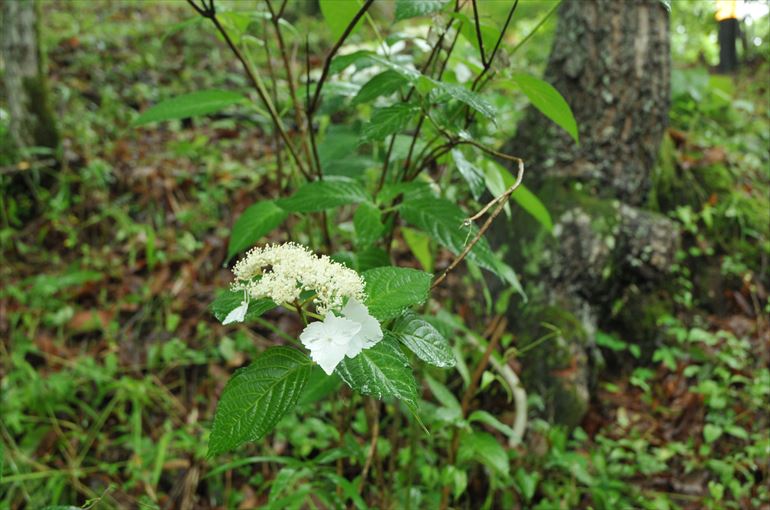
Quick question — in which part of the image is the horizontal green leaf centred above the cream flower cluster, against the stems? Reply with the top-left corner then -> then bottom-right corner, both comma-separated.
276,176 -> 369,212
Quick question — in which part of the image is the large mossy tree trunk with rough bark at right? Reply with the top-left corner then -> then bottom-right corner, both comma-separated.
492,0 -> 678,425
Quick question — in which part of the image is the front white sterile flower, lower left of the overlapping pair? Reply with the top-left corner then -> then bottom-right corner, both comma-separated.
299,313 -> 361,375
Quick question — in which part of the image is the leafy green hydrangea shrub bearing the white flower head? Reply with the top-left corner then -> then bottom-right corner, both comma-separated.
134,0 -> 577,470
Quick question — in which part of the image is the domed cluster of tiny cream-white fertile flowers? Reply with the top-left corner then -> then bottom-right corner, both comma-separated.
233,243 -> 364,314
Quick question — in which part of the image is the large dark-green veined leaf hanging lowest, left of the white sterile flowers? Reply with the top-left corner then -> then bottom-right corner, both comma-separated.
208,347 -> 312,457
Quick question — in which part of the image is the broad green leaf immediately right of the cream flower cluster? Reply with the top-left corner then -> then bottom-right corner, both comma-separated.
362,267 -> 432,321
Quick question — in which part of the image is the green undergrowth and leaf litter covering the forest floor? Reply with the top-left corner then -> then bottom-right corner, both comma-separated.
0,2 -> 770,510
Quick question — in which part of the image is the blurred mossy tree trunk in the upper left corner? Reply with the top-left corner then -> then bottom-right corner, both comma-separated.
0,0 -> 59,149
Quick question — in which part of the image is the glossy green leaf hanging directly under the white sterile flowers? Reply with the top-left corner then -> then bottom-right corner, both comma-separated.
336,336 -> 417,413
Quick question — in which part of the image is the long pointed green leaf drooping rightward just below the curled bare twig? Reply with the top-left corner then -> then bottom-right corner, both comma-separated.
399,197 -> 524,296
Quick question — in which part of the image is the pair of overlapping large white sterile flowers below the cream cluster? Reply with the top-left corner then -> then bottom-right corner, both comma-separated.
299,299 -> 382,375
